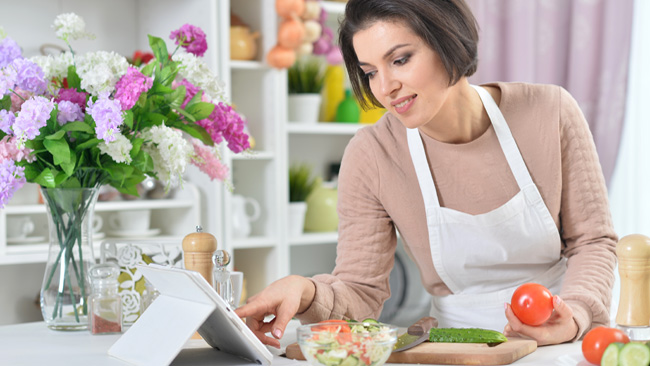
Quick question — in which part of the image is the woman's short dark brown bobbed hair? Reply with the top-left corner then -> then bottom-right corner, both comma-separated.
339,0 -> 478,108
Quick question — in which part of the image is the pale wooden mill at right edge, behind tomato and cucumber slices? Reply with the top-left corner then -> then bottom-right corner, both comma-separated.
616,234 -> 650,341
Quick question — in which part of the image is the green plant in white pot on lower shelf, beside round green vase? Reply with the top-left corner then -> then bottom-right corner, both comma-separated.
288,163 -> 321,236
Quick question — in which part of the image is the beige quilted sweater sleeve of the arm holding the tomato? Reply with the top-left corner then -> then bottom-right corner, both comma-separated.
559,88 -> 618,340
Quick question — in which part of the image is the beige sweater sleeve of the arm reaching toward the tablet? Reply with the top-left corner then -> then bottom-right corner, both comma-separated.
296,130 -> 397,323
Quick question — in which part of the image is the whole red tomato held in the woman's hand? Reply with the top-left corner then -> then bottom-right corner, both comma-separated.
510,283 -> 553,326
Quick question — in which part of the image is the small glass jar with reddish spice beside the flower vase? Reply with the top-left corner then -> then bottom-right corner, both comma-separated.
88,263 -> 122,334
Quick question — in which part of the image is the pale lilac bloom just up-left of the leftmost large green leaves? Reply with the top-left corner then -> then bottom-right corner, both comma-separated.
13,96 -> 54,145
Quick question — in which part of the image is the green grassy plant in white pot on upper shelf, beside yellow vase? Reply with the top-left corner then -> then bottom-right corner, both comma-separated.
288,57 -> 325,123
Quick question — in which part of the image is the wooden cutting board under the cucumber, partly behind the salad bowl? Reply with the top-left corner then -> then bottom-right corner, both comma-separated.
287,338 -> 537,365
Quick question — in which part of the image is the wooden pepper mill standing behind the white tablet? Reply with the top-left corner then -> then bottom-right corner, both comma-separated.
183,226 -> 217,288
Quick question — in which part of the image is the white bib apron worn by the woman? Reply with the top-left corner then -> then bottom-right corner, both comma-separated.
407,85 -> 566,331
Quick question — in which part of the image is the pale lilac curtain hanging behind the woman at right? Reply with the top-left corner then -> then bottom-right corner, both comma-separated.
467,0 -> 634,185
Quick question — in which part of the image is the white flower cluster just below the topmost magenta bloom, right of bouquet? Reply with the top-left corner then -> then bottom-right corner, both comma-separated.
172,53 -> 224,101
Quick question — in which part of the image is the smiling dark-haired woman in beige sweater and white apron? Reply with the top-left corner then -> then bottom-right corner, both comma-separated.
237,0 -> 617,347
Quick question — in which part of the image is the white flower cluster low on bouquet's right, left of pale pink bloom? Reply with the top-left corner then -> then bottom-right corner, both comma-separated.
142,124 -> 194,189
